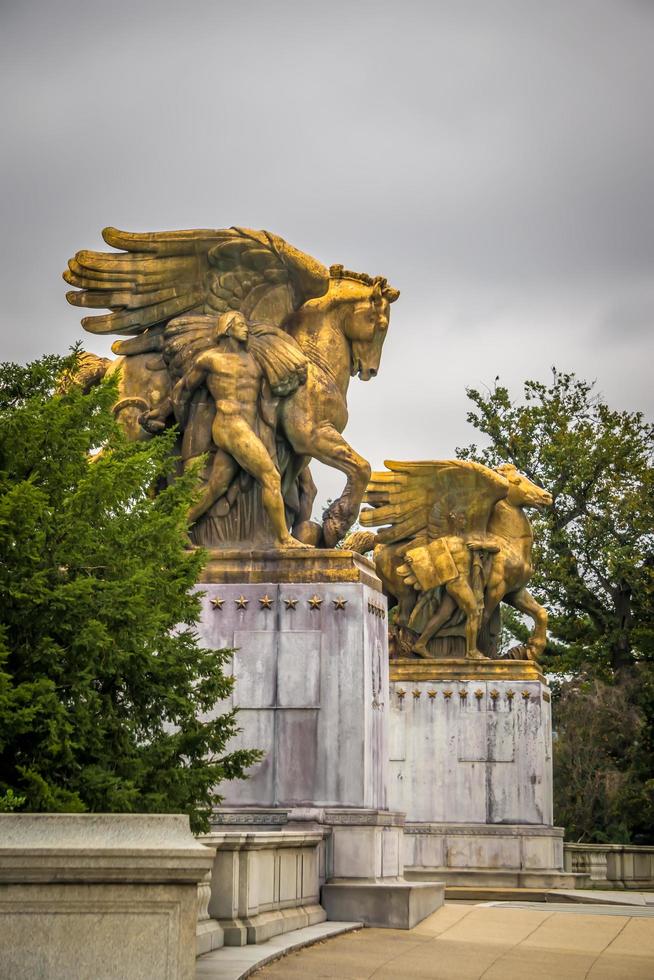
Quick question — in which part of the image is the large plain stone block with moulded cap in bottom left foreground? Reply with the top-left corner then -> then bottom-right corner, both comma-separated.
0,814 -> 213,980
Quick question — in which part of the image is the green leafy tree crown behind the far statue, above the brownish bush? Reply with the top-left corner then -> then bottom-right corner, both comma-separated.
458,371 -> 654,677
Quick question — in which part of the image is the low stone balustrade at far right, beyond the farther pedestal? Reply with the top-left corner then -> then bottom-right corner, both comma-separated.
563,844 -> 654,890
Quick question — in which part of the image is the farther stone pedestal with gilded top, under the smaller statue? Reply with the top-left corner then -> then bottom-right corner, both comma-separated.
389,660 -> 574,887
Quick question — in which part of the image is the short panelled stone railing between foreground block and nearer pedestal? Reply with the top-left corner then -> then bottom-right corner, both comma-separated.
198,830 -> 327,946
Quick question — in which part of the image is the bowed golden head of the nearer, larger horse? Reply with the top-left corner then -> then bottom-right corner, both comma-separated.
328,266 -> 400,381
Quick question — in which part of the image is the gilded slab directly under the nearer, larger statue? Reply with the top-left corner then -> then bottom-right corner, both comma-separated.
200,548 -> 382,592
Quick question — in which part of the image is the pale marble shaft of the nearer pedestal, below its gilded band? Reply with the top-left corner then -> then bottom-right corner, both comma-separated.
199,582 -> 388,808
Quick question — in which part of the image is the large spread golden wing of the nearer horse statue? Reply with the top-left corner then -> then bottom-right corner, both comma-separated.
64,228 -> 329,334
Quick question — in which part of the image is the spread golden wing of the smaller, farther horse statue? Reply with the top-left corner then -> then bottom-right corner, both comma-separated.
359,459 -> 509,544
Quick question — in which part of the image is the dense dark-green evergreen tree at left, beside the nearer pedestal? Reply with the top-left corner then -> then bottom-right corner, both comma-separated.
0,353 -> 258,829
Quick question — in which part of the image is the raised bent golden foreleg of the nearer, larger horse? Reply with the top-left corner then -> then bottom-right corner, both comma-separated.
286,422 -> 370,548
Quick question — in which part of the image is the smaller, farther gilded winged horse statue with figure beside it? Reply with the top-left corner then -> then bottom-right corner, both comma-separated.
346,460 -> 552,660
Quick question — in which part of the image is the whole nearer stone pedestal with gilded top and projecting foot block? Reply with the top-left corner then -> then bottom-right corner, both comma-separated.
200,549 -> 442,928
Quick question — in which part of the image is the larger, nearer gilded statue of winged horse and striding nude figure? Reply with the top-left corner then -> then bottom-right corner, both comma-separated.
64,228 -> 399,548
